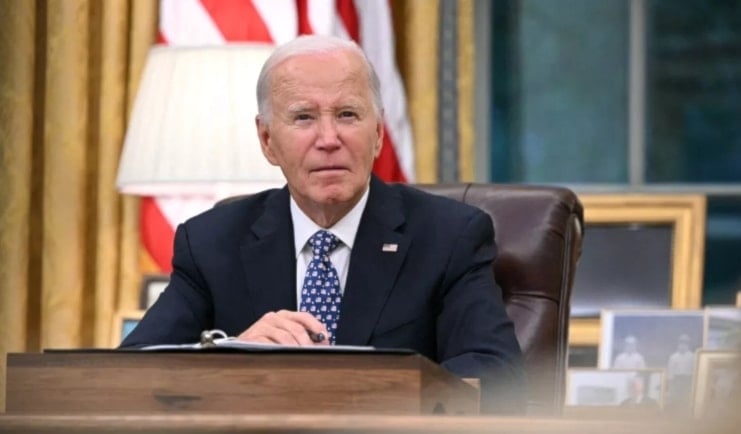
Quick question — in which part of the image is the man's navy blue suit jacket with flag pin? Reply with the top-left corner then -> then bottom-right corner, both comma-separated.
122,177 -> 524,410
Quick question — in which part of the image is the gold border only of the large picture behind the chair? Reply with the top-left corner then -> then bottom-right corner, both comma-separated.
569,193 -> 707,346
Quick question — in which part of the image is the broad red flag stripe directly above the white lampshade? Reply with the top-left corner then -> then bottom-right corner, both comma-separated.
201,0 -> 273,42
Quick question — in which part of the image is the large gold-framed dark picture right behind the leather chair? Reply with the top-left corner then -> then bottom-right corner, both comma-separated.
569,194 -> 706,346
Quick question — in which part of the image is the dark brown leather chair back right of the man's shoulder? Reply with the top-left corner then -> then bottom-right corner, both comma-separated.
416,184 -> 584,414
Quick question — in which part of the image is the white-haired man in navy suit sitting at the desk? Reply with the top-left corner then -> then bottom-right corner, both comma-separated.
122,36 -> 524,411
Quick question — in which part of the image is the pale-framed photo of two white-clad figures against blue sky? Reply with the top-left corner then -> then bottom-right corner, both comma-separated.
598,309 -> 705,413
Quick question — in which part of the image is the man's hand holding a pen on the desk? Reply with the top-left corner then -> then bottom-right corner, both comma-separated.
237,310 -> 329,346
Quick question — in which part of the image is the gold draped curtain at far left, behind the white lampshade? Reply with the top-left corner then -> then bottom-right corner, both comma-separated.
0,0 -> 157,409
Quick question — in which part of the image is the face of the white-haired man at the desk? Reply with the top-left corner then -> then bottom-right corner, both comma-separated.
257,50 -> 383,212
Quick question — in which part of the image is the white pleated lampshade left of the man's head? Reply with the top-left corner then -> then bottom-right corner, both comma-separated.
116,44 -> 285,197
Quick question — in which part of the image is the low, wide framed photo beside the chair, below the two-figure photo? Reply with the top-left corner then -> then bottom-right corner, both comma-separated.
566,368 -> 664,411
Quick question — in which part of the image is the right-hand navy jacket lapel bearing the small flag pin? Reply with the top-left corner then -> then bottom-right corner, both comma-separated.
337,177 -> 411,345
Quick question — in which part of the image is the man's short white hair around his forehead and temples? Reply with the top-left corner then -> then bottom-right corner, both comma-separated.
257,35 -> 383,124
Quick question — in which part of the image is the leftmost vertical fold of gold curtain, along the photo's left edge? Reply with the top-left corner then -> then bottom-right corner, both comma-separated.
0,0 -> 36,403
